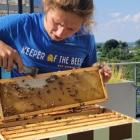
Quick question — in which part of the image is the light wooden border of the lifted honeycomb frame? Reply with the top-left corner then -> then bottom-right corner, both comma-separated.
0,67 -> 108,121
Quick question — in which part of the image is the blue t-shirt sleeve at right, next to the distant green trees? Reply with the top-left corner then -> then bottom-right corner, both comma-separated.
82,35 -> 97,67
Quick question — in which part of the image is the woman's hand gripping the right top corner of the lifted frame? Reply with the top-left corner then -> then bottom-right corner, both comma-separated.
99,64 -> 112,83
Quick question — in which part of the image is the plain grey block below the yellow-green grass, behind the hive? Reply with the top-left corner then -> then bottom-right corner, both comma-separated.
101,81 -> 136,118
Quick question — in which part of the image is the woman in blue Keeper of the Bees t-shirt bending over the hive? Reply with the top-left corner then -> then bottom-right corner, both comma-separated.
0,0 -> 111,81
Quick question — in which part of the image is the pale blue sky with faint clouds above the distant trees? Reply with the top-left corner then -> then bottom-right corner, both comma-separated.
93,0 -> 140,42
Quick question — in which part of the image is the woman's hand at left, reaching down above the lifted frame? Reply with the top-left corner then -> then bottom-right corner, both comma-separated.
0,41 -> 23,73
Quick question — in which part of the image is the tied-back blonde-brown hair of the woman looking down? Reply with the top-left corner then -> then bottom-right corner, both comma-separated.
44,0 -> 94,25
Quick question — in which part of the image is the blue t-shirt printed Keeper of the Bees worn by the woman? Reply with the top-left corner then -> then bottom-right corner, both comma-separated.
0,13 -> 96,77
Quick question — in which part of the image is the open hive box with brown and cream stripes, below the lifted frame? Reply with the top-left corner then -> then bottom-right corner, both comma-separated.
0,105 -> 140,140
